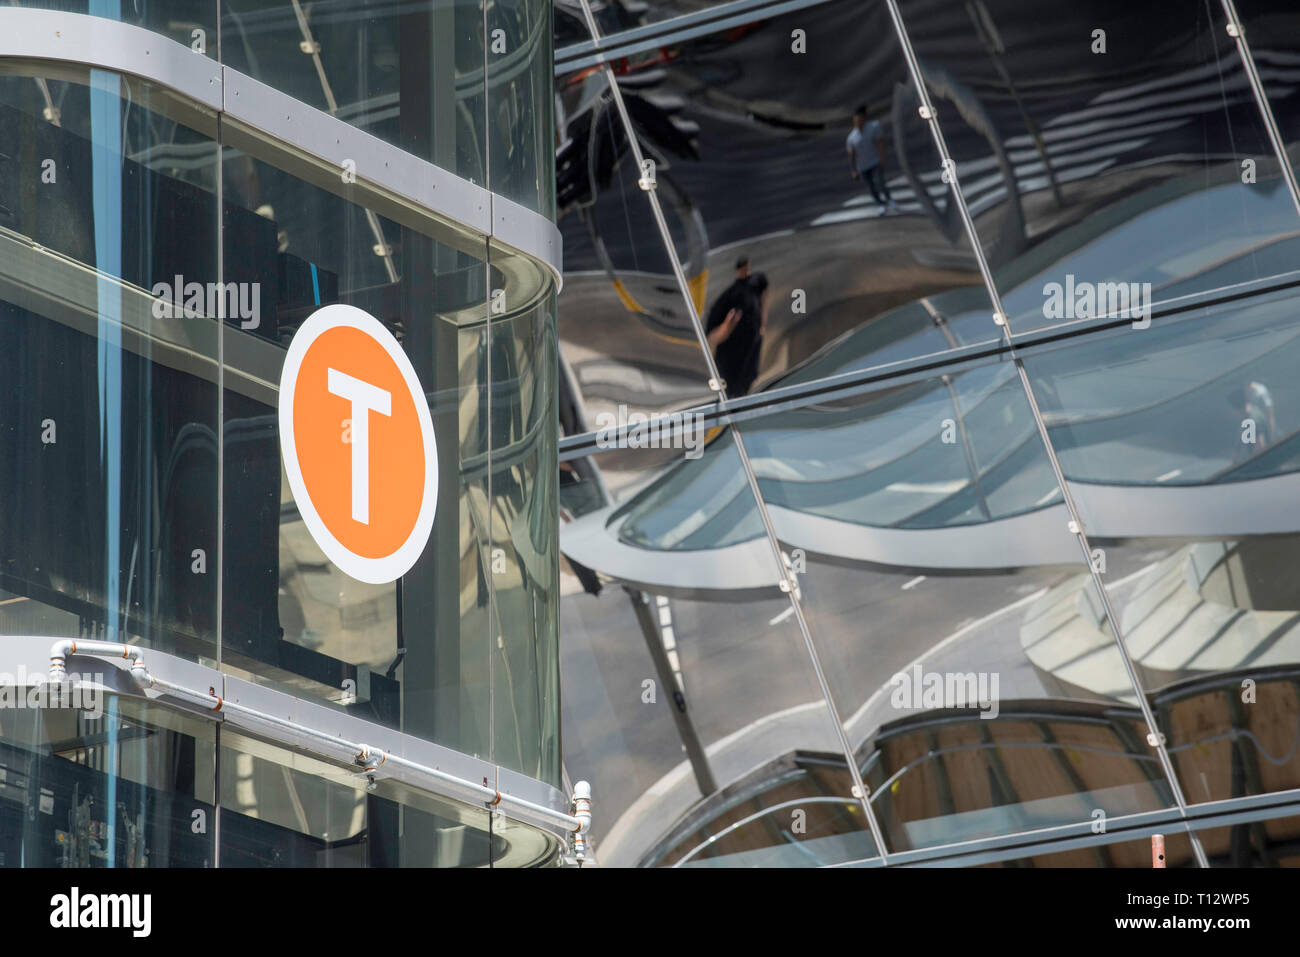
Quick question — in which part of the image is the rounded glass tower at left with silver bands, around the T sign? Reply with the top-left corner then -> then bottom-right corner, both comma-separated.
0,1 -> 568,866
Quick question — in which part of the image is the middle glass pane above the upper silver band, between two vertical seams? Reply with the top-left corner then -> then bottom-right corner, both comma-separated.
221,0 -> 488,186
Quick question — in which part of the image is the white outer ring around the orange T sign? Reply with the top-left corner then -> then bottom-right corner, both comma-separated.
280,303 -> 438,585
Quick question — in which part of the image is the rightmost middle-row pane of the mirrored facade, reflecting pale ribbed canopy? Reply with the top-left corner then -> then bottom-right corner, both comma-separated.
1026,299 -> 1300,801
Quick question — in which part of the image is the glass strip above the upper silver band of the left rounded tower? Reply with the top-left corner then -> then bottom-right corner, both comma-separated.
13,0 -> 555,216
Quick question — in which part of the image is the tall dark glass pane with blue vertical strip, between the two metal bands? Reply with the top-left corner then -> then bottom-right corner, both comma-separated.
0,69 -> 220,659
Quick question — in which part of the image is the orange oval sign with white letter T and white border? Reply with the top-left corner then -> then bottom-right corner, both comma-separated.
280,304 -> 438,584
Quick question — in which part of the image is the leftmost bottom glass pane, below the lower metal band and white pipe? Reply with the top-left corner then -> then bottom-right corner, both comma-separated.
0,696 -> 217,867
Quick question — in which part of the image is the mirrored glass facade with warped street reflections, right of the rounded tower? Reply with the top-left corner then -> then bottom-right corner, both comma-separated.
555,0 -> 1300,866
